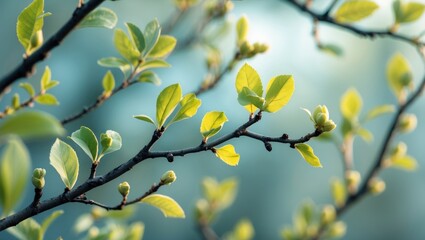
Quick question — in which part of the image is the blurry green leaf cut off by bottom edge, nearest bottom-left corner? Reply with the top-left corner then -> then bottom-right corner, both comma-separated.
7,218 -> 43,240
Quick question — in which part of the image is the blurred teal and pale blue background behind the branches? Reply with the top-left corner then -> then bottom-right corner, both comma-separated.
0,0 -> 425,239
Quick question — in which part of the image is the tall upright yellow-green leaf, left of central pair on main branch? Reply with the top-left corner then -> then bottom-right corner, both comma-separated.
156,83 -> 182,128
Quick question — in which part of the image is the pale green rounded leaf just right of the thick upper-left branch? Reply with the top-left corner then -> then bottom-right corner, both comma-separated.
78,7 -> 118,29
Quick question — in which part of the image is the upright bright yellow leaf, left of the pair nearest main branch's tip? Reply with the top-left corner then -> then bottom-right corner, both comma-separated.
235,63 -> 263,113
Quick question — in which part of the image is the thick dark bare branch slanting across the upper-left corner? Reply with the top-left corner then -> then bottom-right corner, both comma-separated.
0,0 -> 104,92
